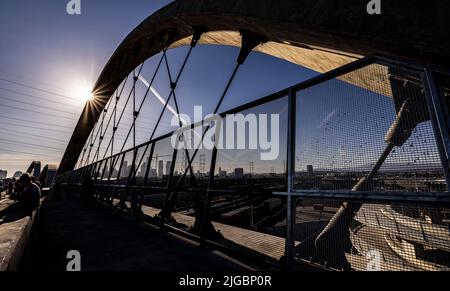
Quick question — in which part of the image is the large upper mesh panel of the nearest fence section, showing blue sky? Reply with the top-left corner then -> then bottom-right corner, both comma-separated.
295,64 -> 448,192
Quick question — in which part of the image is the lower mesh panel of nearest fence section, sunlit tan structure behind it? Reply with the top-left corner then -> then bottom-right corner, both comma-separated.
295,199 -> 450,271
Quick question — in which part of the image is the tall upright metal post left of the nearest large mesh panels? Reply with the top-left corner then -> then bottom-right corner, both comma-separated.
285,89 -> 297,270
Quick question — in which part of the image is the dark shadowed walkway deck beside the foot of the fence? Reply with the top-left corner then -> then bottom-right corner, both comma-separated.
33,198 -> 253,271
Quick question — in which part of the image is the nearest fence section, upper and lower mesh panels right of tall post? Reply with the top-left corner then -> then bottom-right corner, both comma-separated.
288,64 -> 450,271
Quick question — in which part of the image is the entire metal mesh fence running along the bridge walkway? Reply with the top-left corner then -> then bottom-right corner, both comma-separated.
58,56 -> 450,271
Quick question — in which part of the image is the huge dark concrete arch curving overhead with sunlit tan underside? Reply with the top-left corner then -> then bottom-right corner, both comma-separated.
59,0 -> 450,174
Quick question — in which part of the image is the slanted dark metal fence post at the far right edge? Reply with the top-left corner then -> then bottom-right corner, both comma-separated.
422,68 -> 450,187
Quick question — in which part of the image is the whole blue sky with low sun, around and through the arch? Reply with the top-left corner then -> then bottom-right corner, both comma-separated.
0,0 -> 437,180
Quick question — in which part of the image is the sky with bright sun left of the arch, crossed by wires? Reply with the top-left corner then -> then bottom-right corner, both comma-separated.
0,0 -> 170,175
